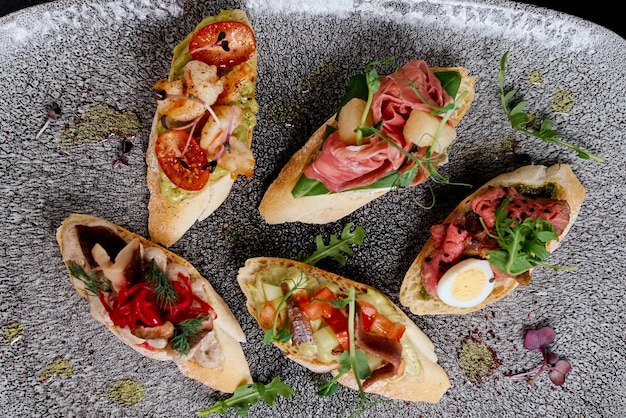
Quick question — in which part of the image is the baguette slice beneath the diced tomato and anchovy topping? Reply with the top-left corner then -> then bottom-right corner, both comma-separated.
237,257 -> 450,403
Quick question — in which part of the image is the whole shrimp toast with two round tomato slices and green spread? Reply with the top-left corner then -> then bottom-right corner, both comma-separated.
146,10 -> 258,247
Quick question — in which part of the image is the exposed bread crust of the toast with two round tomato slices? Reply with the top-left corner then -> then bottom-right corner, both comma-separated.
146,10 -> 258,247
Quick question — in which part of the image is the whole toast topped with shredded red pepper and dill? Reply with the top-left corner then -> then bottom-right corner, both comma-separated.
57,214 -> 252,393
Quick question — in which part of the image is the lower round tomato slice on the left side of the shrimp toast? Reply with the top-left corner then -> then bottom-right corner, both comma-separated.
155,130 -> 211,191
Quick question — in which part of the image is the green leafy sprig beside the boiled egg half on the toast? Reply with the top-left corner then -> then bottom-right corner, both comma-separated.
481,197 -> 572,276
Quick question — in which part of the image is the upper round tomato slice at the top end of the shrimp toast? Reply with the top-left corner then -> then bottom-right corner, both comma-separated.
189,21 -> 256,68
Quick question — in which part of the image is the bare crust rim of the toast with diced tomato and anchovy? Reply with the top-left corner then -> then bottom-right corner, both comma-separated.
237,257 -> 450,403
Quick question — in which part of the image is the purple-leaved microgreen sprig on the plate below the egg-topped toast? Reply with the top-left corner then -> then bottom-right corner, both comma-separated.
504,327 -> 572,386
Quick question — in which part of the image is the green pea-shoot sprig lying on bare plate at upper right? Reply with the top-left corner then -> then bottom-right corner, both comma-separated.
498,51 -> 604,163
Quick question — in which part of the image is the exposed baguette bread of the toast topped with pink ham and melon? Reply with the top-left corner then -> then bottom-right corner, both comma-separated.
259,67 -> 476,224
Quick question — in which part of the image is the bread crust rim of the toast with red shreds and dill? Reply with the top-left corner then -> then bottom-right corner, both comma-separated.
57,214 -> 252,393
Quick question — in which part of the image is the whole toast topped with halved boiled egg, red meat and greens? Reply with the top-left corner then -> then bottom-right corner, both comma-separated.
400,164 -> 585,315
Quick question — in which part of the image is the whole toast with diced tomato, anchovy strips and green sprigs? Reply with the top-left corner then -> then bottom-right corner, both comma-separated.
237,257 -> 450,403
